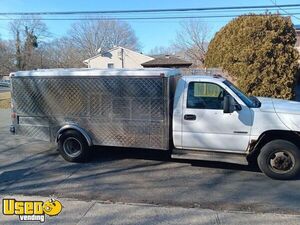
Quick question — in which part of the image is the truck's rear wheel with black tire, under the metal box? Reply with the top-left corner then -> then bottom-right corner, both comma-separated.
58,130 -> 89,162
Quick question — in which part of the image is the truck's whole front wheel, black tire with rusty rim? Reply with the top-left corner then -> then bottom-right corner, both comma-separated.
257,140 -> 300,180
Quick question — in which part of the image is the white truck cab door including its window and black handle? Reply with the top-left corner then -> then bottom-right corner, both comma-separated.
182,81 -> 252,152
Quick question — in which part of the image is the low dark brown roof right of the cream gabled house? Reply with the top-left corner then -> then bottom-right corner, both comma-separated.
142,55 -> 192,68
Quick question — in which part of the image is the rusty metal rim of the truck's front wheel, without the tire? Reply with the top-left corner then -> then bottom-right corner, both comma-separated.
268,150 -> 295,174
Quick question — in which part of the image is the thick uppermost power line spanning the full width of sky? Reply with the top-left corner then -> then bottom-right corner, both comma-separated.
0,4 -> 300,16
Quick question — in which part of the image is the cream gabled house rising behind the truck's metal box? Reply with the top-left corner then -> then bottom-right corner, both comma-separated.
83,46 -> 154,69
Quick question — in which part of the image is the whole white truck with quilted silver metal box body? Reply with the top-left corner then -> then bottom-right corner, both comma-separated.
10,68 -> 300,179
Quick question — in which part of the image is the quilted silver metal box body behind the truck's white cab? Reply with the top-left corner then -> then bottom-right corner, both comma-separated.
11,69 -> 180,150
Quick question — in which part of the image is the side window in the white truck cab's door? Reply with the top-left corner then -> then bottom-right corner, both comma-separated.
187,82 -> 228,110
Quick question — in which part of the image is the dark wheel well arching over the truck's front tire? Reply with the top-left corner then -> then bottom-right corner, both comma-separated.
248,130 -> 300,160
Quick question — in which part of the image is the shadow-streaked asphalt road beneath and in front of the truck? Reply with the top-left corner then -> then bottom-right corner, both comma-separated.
0,110 -> 300,215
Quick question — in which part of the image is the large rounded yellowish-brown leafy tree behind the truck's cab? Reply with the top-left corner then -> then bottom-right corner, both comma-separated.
205,14 -> 299,99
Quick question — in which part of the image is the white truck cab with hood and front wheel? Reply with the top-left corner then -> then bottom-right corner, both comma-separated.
173,75 -> 300,179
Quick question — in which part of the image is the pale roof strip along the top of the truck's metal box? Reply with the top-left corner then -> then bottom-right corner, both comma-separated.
10,68 -> 180,77
